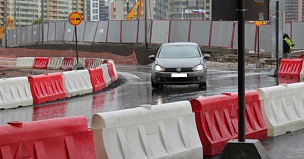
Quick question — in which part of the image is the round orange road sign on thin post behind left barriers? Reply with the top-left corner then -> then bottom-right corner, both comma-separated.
69,12 -> 84,70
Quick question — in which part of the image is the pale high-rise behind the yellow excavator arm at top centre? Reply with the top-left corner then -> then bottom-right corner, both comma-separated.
114,0 -> 167,20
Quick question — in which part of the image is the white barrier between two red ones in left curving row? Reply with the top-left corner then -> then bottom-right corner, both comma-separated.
62,70 -> 93,97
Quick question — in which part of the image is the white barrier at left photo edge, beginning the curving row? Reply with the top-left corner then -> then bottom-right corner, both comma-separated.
0,77 -> 33,109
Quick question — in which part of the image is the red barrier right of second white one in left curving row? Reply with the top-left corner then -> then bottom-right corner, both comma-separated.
89,67 -> 106,92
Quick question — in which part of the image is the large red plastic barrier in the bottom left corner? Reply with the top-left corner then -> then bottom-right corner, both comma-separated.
0,116 -> 96,159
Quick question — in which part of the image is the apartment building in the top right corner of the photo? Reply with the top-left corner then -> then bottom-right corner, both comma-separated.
283,0 -> 304,23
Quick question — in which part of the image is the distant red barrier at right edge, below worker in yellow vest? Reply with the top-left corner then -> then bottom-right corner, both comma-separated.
278,59 -> 303,78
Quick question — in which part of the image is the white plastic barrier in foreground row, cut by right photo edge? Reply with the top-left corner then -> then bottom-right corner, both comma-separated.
257,83 -> 304,137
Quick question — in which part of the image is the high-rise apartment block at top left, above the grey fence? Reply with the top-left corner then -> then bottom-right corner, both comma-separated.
4,0 -> 86,27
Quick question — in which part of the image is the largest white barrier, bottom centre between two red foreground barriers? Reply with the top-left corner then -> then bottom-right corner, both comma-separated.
91,101 -> 203,159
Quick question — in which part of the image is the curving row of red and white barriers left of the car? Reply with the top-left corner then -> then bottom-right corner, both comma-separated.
0,57 -> 118,109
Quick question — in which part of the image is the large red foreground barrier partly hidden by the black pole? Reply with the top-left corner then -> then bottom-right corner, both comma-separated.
190,90 -> 267,156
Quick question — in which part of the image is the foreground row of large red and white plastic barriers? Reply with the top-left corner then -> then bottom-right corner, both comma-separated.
0,80 -> 304,159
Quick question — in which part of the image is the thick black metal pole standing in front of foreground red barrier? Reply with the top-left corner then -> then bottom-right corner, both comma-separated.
238,0 -> 245,141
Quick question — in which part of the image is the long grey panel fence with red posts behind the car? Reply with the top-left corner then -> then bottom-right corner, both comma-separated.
2,20 -> 304,52
